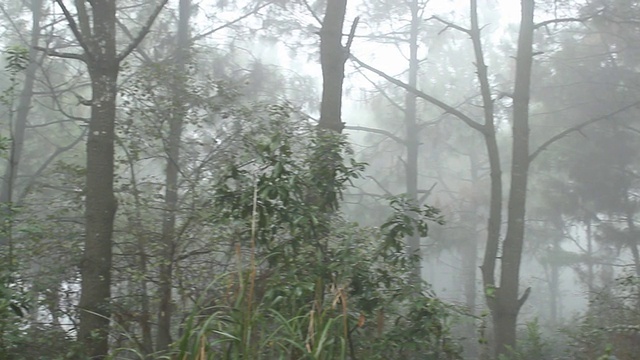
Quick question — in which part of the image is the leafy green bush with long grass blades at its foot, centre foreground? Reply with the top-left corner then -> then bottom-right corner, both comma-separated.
139,109 -> 459,359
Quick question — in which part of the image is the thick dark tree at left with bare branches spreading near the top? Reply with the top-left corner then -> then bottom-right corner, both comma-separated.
49,0 -> 168,359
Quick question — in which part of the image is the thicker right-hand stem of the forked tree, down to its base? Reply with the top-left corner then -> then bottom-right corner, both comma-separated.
494,0 -> 535,355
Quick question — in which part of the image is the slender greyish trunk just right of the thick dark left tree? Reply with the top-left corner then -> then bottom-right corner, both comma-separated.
156,0 -> 191,351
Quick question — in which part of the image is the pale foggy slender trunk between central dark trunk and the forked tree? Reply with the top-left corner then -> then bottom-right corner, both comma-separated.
404,0 -> 422,285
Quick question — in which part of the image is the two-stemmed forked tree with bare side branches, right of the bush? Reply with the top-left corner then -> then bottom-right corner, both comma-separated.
354,0 -> 628,356
